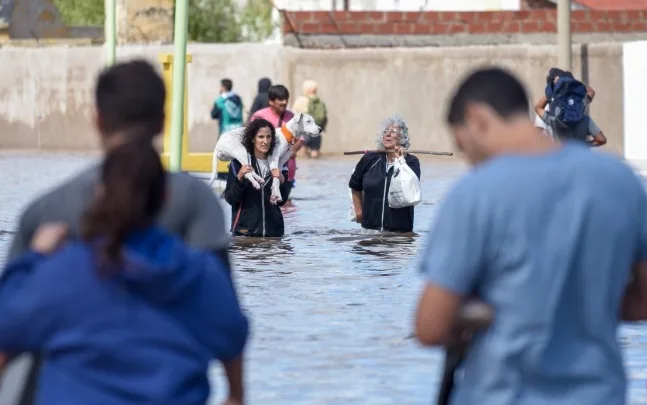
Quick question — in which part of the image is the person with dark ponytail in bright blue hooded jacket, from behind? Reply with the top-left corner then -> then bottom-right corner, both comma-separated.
0,141 -> 249,405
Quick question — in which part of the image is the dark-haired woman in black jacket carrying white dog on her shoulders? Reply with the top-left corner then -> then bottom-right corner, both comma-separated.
224,118 -> 290,237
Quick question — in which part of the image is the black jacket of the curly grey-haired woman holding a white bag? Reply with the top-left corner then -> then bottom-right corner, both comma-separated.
348,152 -> 420,232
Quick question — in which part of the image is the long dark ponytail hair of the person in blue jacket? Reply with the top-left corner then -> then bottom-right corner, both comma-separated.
81,140 -> 166,270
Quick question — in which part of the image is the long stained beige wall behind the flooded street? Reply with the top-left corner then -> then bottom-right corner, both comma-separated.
0,44 -> 623,153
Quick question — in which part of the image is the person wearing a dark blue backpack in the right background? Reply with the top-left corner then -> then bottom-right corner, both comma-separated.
535,68 -> 607,147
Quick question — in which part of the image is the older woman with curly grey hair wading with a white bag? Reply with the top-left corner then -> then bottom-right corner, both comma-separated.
348,115 -> 420,232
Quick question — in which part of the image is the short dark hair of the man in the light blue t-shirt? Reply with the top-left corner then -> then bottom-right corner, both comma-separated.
447,68 -> 530,125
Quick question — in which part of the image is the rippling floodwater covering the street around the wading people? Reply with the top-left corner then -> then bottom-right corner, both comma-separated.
0,154 -> 647,405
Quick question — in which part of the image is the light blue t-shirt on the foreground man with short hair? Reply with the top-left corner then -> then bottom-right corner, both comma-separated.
422,144 -> 647,405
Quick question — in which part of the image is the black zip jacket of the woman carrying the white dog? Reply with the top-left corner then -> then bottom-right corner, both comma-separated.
224,156 -> 289,237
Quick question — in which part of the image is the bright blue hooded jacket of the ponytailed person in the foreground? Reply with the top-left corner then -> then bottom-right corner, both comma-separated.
0,228 -> 248,405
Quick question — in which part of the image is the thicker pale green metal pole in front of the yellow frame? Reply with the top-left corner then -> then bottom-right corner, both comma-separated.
169,0 -> 189,172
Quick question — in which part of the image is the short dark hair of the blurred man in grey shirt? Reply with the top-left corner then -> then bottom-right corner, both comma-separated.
95,60 -> 166,141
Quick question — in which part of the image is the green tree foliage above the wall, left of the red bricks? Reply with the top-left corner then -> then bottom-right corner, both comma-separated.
55,0 -> 275,43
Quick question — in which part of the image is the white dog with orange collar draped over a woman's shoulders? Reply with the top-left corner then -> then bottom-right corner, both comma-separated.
209,113 -> 321,204
